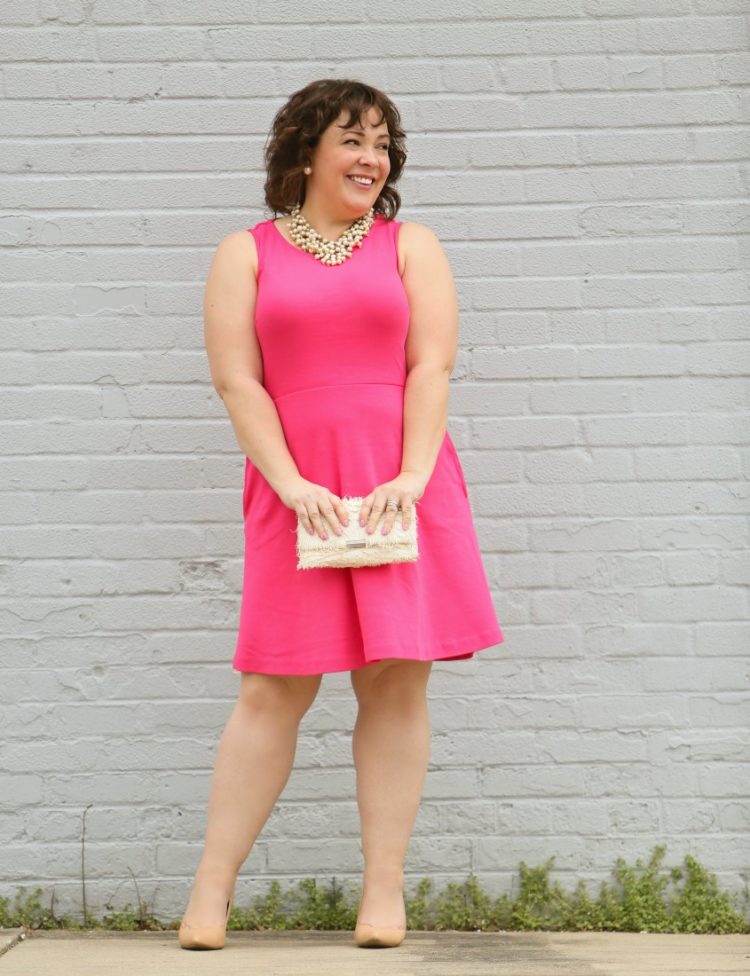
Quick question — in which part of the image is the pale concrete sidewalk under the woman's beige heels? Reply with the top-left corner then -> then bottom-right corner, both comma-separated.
0,929 -> 750,976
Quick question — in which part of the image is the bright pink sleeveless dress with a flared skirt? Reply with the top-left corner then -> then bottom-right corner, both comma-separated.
232,214 -> 504,675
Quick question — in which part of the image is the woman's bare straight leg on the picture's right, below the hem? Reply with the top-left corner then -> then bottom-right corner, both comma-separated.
351,659 -> 432,927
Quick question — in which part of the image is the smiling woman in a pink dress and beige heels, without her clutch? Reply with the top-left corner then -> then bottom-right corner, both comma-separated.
180,79 -> 504,948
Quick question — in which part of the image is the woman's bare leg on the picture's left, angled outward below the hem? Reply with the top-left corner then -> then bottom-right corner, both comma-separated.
183,673 -> 322,926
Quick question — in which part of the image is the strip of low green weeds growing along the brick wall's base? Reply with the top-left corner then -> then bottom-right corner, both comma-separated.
0,845 -> 750,934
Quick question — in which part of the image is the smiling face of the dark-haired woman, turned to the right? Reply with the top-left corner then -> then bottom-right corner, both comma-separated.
305,106 -> 391,217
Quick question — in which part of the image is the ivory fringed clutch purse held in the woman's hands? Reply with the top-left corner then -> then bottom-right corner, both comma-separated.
297,496 -> 419,569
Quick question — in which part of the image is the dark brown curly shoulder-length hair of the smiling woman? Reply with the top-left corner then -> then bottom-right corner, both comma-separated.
263,78 -> 406,220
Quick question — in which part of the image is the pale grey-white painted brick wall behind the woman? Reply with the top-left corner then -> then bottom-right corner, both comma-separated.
0,0 -> 750,918
